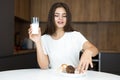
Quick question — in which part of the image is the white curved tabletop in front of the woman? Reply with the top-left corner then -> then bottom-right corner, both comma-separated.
0,69 -> 120,80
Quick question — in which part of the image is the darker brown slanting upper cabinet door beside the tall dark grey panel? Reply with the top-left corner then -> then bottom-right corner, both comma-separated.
14,0 -> 30,21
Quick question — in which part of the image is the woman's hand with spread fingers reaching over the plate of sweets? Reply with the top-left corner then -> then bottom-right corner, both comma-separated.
77,49 -> 93,73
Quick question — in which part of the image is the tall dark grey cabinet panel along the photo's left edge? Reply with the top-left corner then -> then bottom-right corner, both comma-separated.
0,0 -> 14,57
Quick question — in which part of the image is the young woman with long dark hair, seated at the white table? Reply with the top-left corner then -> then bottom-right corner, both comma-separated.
29,3 -> 98,73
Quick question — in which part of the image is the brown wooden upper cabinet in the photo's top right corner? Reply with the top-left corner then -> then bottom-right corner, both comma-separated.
100,0 -> 120,21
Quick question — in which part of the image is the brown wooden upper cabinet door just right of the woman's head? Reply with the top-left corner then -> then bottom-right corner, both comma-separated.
71,0 -> 99,22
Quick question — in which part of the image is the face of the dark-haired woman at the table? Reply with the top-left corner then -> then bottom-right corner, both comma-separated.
54,7 -> 67,28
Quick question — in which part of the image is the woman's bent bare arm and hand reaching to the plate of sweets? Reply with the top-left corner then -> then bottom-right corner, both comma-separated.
77,41 -> 98,73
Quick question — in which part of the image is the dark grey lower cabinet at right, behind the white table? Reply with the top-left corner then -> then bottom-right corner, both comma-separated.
101,51 -> 120,75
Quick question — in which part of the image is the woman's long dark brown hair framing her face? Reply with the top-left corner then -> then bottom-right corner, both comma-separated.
43,2 -> 74,35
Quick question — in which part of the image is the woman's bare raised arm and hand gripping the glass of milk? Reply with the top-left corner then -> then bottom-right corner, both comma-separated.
28,27 -> 49,69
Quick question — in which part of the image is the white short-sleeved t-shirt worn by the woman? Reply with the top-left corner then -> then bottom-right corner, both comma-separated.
42,31 -> 87,68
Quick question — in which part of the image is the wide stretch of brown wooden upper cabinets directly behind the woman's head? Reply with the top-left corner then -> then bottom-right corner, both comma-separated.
31,0 -> 99,22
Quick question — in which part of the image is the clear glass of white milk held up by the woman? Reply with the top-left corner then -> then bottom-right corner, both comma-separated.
31,17 -> 39,34
